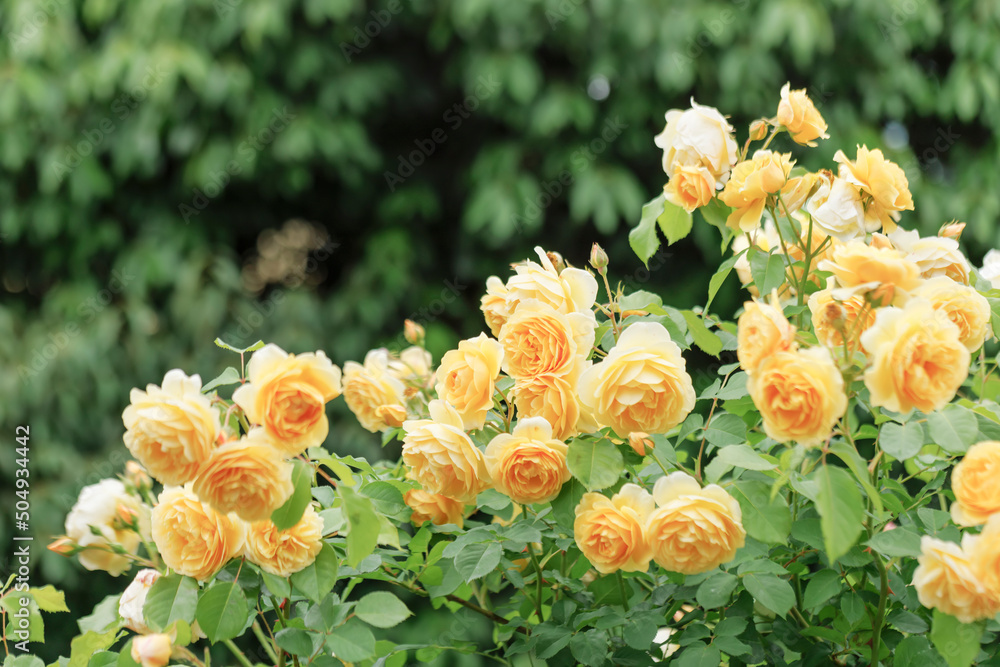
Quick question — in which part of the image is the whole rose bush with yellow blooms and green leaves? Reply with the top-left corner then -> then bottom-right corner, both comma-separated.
11,85 -> 1000,667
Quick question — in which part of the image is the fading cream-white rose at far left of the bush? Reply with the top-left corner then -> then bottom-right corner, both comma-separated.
66,479 -> 149,577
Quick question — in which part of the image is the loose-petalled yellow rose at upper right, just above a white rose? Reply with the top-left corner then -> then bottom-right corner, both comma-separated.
833,146 -> 913,232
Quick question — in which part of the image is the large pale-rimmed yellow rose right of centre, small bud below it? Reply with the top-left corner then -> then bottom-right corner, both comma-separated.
577,322 -> 695,436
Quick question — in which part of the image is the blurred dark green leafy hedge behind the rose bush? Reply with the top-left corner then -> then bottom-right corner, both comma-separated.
0,0 -> 1000,660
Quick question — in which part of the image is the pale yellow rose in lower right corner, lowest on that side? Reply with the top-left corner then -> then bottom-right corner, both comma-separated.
913,535 -> 1000,623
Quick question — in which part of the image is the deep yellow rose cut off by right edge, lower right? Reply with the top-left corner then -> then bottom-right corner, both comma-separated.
951,440 -> 1000,526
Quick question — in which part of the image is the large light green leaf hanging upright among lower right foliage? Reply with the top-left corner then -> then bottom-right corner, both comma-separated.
813,464 -> 865,563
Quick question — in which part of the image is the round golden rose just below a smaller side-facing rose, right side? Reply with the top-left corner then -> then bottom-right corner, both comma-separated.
747,347 -> 847,445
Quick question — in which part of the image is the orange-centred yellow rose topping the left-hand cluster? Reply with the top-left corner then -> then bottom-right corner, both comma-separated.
233,344 -> 340,456
